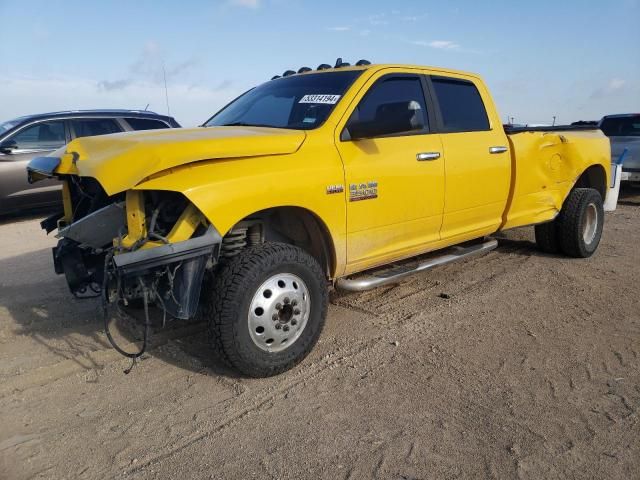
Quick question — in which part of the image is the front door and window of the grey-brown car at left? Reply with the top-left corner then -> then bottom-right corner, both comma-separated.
0,120 -> 68,212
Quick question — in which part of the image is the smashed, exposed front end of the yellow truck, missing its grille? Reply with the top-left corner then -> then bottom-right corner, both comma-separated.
29,157 -> 221,319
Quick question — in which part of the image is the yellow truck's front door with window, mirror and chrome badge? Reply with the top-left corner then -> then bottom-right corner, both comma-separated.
336,70 -> 444,273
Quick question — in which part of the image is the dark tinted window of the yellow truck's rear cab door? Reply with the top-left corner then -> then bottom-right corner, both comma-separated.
431,77 -> 489,132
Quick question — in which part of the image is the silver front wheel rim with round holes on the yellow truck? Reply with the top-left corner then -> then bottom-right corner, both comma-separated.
248,273 -> 311,353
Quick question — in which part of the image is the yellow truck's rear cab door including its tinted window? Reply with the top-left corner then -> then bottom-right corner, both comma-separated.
429,75 -> 511,243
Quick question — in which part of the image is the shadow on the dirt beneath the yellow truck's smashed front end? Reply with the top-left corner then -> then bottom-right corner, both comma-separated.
0,248 -> 238,378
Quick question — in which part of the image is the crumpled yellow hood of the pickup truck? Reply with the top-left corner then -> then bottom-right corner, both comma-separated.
56,127 -> 306,195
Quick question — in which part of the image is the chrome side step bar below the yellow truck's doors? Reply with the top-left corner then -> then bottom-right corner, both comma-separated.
336,239 -> 498,292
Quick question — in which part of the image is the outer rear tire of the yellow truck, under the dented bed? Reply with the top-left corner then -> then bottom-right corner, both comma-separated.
556,188 -> 604,258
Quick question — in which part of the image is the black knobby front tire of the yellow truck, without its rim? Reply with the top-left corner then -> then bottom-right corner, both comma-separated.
202,242 -> 328,377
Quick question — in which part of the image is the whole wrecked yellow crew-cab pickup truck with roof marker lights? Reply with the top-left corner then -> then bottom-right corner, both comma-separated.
28,60 -> 611,376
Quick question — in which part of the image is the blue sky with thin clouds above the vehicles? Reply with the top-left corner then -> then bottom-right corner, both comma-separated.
0,0 -> 640,126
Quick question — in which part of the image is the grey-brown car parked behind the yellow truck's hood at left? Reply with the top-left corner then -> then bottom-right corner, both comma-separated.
0,110 -> 180,214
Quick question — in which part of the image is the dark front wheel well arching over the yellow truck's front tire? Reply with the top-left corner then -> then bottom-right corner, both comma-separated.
223,207 -> 336,277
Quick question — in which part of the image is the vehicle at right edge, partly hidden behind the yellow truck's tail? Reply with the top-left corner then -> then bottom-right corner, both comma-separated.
598,113 -> 640,182
